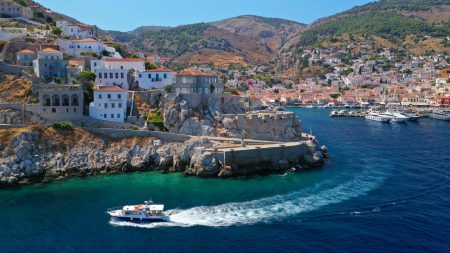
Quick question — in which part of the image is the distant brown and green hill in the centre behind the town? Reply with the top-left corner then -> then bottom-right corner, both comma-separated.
100,16 -> 305,66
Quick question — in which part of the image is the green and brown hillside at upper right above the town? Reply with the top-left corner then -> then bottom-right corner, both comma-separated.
276,0 -> 450,77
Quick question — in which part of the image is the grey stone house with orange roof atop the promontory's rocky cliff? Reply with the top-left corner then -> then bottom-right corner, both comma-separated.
172,69 -> 224,94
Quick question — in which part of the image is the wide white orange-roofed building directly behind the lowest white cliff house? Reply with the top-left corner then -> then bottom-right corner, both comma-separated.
91,58 -> 145,89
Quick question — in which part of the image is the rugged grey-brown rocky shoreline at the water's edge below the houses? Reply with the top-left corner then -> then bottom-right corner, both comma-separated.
0,126 -> 326,188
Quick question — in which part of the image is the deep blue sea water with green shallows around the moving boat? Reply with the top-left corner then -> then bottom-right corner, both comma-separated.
0,109 -> 450,253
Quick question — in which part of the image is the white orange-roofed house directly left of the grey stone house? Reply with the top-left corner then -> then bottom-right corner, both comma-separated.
135,68 -> 175,90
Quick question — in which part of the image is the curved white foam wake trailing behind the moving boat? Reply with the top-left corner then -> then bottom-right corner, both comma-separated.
110,170 -> 385,228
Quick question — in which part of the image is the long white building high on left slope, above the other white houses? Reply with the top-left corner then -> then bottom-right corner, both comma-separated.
59,38 -> 116,58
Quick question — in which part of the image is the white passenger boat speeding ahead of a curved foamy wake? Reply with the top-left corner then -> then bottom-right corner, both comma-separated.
106,200 -> 170,222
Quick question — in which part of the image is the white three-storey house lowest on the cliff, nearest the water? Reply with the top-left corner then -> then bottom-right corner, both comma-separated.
89,86 -> 128,122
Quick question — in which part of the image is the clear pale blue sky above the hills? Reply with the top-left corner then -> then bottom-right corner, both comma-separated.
37,0 -> 373,31
